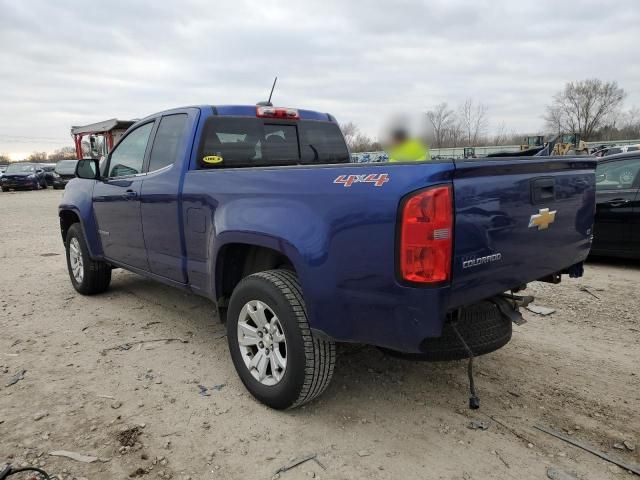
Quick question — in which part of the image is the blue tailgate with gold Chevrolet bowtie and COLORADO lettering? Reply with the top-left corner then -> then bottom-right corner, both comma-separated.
450,157 -> 596,308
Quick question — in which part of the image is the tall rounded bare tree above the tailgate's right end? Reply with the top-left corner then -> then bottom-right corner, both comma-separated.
545,78 -> 626,140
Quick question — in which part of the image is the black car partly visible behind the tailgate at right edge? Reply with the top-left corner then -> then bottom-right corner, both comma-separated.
591,152 -> 640,258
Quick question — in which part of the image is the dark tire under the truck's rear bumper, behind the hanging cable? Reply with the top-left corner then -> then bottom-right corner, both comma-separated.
383,301 -> 512,362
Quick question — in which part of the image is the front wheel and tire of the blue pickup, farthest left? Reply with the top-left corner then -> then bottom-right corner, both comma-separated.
65,223 -> 111,295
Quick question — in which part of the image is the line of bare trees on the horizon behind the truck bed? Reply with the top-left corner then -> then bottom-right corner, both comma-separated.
341,79 -> 640,152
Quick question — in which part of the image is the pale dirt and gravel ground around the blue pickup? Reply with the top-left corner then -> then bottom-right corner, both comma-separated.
0,190 -> 640,480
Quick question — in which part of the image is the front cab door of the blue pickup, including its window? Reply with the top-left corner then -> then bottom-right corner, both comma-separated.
93,121 -> 154,271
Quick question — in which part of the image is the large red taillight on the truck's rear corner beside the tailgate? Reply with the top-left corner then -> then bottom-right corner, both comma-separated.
399,186 -> 453,283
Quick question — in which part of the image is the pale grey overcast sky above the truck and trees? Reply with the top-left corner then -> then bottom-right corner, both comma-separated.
0,0 -> 640,157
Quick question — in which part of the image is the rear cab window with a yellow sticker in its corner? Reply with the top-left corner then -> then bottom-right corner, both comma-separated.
199,116 -> 350,168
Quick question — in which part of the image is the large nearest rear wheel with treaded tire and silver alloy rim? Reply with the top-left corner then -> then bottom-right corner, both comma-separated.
227,270 -> 336,410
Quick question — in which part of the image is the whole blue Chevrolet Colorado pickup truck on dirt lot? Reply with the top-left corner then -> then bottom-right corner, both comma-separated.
59,104 -> 596,409
